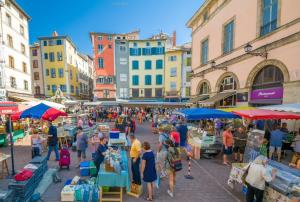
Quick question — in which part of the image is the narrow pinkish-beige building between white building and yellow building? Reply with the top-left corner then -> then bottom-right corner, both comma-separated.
30,43 -> 45,98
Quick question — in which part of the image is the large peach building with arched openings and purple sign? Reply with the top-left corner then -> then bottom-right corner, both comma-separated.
187,0 -> 300,107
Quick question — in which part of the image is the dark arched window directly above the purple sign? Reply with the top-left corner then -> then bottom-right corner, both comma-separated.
252,65 -> 284,90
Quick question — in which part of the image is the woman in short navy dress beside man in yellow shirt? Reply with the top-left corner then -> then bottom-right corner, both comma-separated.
141,142 -> 157,201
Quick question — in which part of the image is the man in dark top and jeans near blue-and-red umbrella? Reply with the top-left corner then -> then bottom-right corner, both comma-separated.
47,121 -> 59,161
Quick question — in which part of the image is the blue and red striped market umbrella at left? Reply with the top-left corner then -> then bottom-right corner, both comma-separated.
12,103 -> 68,121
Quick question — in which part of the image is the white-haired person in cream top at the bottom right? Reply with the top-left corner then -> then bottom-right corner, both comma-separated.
244,155 -> 276,202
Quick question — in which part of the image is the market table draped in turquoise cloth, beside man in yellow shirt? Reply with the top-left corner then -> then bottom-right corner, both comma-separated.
96,151 -> 130,202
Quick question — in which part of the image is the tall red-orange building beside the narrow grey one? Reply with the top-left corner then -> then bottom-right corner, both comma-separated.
90,31 -> 139,100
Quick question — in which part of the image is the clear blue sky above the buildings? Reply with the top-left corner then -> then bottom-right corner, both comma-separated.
17,0 -> 204,55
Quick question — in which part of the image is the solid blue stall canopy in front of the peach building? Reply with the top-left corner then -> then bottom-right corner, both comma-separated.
175,108 -> 240,121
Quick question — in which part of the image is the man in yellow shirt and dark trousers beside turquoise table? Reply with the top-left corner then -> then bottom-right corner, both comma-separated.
129,134 -> 142,185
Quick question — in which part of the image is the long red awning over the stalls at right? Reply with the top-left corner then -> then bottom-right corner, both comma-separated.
233,109 -> 300,120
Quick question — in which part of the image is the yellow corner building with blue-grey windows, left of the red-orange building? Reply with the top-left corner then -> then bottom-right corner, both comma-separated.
39,32 -> 79,98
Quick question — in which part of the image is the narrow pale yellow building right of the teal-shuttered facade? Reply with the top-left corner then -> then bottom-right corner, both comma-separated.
164,47 -> 183,101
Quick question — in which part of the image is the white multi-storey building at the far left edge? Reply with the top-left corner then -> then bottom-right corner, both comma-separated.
0,0 -> 32,101
